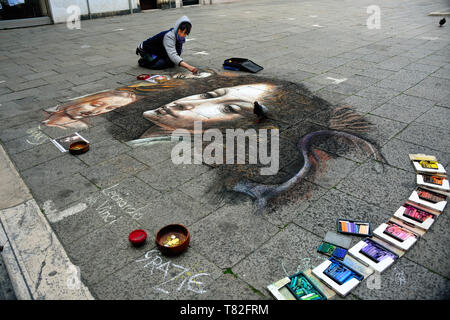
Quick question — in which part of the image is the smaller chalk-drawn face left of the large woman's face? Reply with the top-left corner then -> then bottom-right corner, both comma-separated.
65,92 -> 136,119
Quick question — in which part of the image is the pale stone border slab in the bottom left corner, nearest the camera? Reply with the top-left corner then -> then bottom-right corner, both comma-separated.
0,200 -> 92,300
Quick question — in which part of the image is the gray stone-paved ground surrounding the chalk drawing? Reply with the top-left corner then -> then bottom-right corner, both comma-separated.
0,0 -> 450,300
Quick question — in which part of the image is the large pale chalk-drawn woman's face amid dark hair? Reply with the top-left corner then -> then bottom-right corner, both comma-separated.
144,83 -> 274,129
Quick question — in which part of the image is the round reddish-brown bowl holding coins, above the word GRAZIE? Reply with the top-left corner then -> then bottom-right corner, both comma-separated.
155,224 -> 191,256
